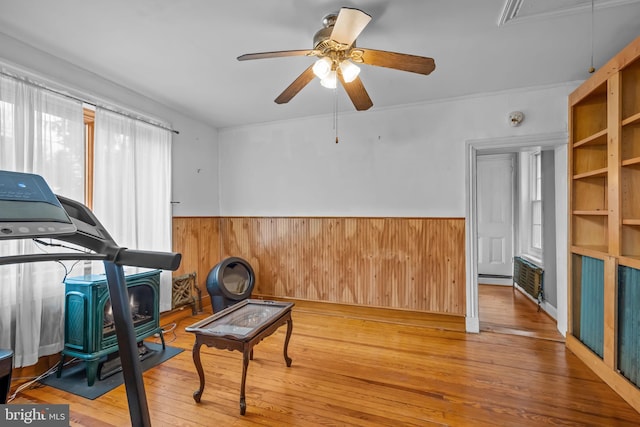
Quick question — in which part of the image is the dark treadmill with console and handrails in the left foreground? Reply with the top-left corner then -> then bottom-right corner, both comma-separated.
0,170 -> 182,427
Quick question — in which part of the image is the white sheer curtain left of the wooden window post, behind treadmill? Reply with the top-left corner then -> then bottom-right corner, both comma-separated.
0,76 -> 84,367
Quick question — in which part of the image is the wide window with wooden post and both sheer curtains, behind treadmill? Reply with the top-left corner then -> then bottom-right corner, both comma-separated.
0,73 -> 171,367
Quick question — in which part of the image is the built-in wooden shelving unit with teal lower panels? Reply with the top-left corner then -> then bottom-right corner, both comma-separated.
567,37 -> 640,411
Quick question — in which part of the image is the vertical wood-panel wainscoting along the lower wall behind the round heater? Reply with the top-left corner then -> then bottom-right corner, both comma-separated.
173,217 -> 465,316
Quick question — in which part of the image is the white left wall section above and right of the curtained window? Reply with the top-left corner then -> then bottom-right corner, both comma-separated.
0,33 -> 220,216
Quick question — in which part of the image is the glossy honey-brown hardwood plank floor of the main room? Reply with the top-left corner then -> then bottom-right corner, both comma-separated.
6,290 -> 640,427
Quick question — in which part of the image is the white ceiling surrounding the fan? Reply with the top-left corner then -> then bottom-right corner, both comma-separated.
0,0 -> 640,127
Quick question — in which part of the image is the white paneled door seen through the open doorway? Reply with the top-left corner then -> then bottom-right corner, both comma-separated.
476,154 -> 514,277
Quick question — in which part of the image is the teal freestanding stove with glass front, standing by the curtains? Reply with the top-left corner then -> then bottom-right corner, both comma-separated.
57,269 -> 165,386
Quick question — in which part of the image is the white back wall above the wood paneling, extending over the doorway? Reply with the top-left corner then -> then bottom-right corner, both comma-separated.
218,83 -> 578,217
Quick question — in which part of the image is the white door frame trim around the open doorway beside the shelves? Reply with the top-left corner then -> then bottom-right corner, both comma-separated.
466,132 -> 567,335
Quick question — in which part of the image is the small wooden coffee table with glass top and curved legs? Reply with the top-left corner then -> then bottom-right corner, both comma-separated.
185,299 -> 294,415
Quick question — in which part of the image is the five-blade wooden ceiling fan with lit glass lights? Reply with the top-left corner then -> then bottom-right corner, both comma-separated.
238,7 -> 436,111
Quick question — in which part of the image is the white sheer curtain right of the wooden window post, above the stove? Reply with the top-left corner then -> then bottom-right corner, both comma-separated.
93,108 -> 171,311
